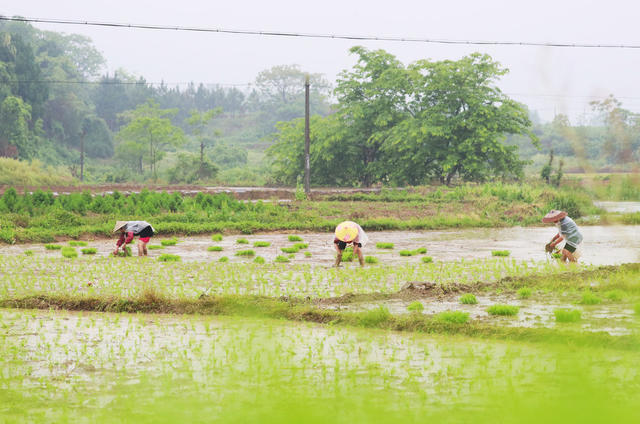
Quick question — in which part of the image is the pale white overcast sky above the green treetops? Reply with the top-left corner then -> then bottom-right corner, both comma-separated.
0,0 -> 640,122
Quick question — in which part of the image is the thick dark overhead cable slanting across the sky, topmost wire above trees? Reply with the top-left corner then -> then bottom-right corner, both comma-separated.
0,16 -> 640,49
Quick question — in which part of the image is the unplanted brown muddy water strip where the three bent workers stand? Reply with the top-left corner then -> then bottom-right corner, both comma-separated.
0,225 -> 640,266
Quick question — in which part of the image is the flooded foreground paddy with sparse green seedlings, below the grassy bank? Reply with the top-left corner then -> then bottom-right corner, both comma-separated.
0,309 -> 640,422
